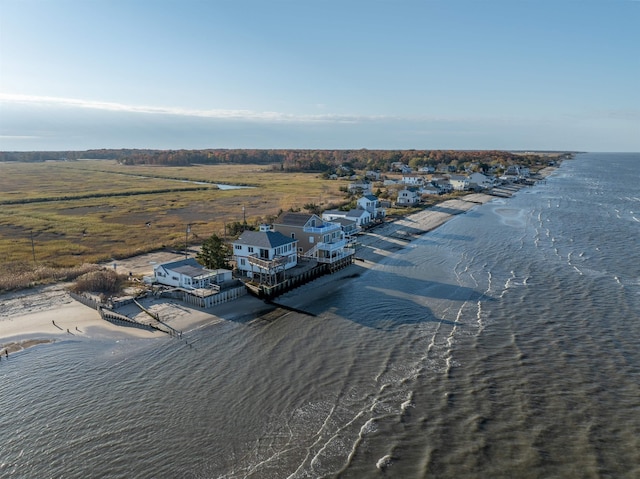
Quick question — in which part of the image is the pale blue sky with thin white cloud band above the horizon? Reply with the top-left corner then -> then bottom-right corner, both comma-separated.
0,0 -> 640,151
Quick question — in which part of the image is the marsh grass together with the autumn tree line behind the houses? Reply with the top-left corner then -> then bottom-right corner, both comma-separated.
0,150 -> 557,290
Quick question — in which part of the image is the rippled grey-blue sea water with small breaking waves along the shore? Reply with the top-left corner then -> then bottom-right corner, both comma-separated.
0,153 -> 640,478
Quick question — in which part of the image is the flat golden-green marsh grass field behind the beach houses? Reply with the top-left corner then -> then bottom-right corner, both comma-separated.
0,160 -> 345,269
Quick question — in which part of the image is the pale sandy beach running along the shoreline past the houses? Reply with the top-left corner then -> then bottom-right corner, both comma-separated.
0,194 -> 493,354
